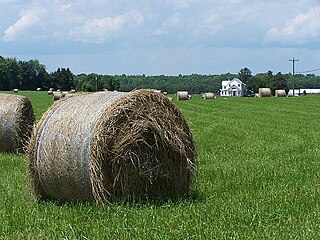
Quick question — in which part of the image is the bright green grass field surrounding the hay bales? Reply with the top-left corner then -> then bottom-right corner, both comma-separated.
0,92 -> 320,239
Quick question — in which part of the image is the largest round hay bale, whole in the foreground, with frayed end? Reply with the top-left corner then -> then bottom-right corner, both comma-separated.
29,90 -> 195,203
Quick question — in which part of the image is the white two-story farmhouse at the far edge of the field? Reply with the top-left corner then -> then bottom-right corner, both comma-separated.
220,78 -> 245,97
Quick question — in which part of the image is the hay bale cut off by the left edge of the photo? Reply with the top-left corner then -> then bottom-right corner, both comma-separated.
0,94 -> 35,153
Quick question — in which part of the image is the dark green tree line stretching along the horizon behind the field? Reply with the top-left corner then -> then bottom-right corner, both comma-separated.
0,56 -> 320,96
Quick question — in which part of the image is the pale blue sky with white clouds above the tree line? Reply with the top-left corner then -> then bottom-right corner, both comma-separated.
0,0 -> 320,75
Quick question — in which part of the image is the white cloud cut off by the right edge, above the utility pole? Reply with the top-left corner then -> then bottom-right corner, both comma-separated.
266,6 -> 320,44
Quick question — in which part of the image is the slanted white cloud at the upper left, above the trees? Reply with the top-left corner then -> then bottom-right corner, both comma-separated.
2,7 -> 45,42
